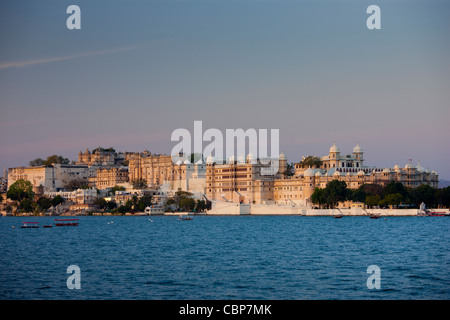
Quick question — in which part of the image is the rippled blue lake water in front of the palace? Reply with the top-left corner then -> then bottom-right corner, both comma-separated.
0,216 -> 450,300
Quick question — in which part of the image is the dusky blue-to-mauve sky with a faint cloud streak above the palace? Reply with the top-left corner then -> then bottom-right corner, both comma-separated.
0,0 -> 450,180
